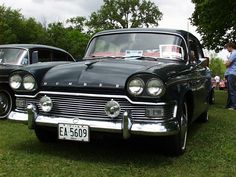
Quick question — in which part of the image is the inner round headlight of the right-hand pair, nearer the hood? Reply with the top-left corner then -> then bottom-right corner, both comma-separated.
128,78 -> 145,96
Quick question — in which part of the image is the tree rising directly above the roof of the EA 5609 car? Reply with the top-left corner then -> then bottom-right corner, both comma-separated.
87,0 -> 162,30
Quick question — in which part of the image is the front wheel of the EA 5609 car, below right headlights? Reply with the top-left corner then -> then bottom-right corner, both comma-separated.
171,101 -> 188,155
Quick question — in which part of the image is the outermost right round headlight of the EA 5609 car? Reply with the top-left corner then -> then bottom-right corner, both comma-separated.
147,79 -> 165,96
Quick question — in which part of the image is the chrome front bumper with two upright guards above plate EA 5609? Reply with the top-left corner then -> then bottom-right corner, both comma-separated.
8,105 -> 180,139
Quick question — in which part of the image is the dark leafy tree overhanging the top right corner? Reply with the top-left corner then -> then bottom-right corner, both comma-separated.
191,0 -> 236,51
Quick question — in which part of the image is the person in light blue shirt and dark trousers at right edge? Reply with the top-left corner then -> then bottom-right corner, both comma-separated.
225,42 -> 236,110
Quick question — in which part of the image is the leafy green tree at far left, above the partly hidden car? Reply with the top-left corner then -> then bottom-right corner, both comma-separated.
0,6 -> 48,44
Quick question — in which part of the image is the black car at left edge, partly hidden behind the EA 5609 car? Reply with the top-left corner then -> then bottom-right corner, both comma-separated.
0,44 -> 74,119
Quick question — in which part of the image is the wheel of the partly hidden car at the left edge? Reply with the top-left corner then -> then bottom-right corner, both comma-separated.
0,90 -> 13,119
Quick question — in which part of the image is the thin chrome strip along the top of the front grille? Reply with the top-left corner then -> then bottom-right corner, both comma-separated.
15,91 -> 166,106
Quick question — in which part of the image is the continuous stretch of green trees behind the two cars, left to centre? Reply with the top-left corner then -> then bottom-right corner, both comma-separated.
0,0 -> 162,59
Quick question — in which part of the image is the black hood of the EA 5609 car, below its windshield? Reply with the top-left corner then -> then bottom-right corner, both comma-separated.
42,59 -> 184,88
